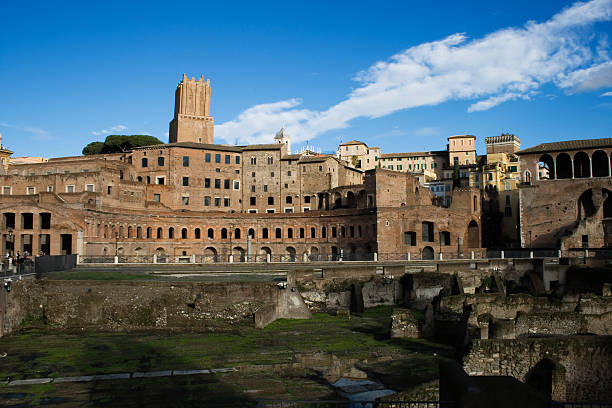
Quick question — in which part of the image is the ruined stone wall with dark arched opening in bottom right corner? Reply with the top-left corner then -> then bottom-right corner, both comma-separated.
463,336 -> 612,401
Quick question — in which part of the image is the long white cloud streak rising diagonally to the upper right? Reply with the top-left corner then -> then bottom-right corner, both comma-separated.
215,0 -> 612,143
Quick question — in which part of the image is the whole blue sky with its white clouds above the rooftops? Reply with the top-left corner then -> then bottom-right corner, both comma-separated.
0,0 -> 612,157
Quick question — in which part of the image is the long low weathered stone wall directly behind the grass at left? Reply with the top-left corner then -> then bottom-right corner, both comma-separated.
0,280 -> 310,334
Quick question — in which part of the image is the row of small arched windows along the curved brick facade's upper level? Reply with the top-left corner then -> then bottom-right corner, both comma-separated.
93,224 -> 375,240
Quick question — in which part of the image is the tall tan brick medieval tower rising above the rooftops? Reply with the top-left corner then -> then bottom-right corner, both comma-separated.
170,74 -> 214,143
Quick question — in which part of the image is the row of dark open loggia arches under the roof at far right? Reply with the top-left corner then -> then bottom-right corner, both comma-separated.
538,150 -> 612,180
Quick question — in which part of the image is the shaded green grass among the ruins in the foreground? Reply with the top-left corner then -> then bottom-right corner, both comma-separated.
0,306 -> 452,406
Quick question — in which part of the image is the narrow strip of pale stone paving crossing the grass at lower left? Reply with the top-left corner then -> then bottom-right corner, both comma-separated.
0,367 -> 238,386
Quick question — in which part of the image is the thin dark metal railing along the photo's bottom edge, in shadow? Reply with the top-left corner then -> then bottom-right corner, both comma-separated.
256,399 -> 454,408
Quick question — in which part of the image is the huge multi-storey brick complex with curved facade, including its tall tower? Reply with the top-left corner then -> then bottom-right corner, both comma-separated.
0,76 -> 482,261
